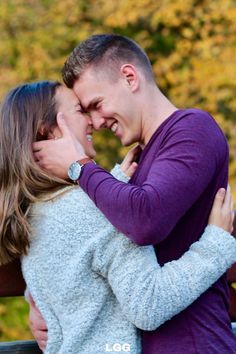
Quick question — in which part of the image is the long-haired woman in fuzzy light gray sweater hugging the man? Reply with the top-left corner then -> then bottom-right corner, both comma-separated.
0,82 -> 236,354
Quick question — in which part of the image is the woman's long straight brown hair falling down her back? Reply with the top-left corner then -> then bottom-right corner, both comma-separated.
0,81 -> 68,264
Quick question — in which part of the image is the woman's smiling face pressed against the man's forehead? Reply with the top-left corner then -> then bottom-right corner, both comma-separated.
53,86 -> 96,158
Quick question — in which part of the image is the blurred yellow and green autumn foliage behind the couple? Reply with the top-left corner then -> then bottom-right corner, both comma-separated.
0,0 -> 236,341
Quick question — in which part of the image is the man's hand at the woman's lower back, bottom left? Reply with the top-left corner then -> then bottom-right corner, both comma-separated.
28,294 -> 48,351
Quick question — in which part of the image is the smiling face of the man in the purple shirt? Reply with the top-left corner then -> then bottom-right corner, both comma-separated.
73,68 -> 141,146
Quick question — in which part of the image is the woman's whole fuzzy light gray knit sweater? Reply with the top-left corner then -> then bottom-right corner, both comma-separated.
22,168 -> 236,354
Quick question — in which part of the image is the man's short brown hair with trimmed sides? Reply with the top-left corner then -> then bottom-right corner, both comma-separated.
62,34 -> 154,88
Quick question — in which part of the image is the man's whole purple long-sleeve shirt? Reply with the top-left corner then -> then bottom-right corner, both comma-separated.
80,109 -> 236,354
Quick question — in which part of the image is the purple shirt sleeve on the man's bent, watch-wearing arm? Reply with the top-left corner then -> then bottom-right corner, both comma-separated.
80,117 -> 227,245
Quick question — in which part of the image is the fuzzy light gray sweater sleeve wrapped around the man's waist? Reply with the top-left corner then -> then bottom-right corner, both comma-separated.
93,225 -> 236,330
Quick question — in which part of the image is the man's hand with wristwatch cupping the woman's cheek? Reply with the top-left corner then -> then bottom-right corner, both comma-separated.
33,112 -> 87,179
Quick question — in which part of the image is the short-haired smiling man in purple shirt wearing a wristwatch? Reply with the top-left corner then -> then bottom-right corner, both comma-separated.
34,35 -> 236,354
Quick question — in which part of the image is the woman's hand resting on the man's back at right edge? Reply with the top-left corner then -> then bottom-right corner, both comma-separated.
208,186 -> 234,233
